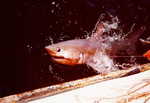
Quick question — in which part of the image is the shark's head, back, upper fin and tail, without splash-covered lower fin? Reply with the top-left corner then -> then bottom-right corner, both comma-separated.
45,17 -> 145,72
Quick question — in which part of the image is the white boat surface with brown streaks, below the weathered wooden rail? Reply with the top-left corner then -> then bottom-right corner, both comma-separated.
29,70 -> 150,103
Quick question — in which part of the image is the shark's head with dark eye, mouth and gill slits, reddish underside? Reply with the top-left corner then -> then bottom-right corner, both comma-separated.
45,40 -> 94,65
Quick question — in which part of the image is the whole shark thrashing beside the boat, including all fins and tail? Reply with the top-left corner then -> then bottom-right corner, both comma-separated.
45,17 -> 145,73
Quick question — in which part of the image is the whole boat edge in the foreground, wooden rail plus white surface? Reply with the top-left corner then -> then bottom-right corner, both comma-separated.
0,64 -> 150,103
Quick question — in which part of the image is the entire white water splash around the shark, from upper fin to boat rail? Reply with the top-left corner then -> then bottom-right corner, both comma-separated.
87,16 -> 142,74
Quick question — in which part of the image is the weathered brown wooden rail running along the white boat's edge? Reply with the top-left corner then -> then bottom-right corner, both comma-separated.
0,63 -> 150,103
